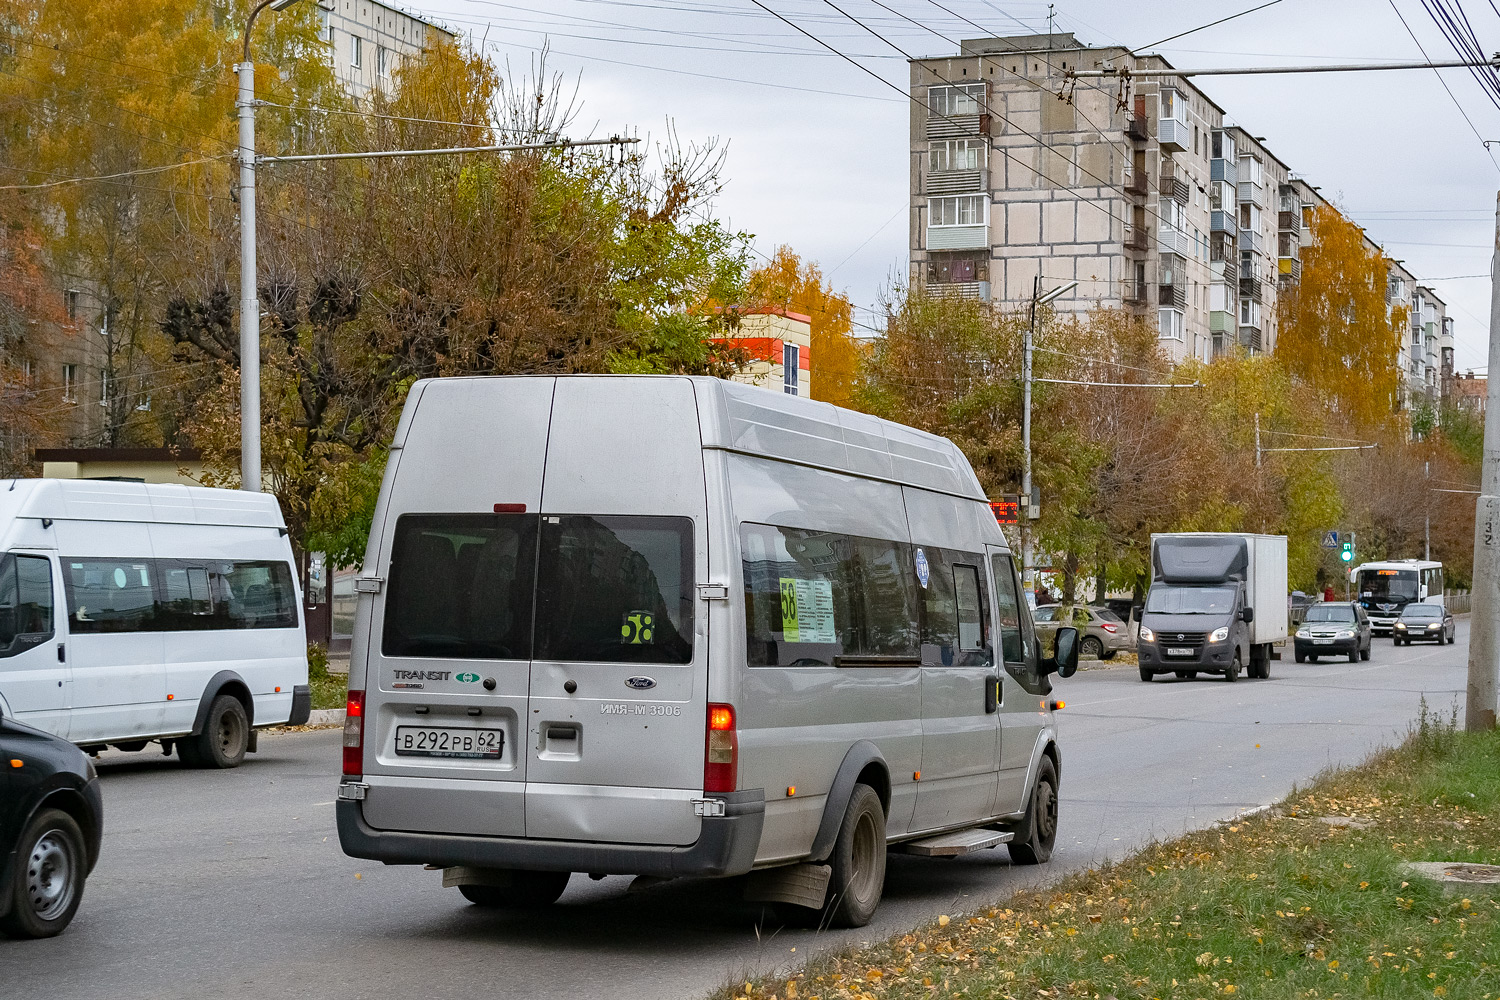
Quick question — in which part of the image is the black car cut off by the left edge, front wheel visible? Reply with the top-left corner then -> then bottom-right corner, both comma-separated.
0,718 -> 104,937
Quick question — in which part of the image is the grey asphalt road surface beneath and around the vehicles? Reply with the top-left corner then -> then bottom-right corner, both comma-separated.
0,622 -> 1469,1000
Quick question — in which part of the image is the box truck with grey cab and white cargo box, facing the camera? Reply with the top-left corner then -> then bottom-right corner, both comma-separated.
1137,532 -> 1287,681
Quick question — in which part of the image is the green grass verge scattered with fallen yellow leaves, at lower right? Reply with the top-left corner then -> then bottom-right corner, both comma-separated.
716,703 -> 1500,1000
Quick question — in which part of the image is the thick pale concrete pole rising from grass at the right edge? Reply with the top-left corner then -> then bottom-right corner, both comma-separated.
1464,195 -> 1500,732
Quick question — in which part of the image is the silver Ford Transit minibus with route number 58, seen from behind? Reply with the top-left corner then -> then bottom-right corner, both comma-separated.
338,376 -> 1077,927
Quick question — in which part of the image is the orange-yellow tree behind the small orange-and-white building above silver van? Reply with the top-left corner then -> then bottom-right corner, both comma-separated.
749,246 -> 863,406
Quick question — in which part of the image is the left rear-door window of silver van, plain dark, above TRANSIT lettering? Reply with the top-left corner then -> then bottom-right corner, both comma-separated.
381,514 -> 537,660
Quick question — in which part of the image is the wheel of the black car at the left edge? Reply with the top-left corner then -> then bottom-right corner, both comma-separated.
0,810 -> 89,937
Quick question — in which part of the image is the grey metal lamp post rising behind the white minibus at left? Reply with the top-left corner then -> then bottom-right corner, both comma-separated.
234,0 -> 297,493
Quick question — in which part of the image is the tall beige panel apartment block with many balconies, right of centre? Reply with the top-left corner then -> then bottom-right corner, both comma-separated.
911,33 -> 1452,413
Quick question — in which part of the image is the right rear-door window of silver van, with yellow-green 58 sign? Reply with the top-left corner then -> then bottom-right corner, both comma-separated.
536,514 -> 695,663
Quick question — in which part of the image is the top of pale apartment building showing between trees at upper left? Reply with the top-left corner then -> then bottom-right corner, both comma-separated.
318,0 -> 456,100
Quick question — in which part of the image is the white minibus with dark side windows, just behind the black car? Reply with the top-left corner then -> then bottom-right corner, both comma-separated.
0,480 -> 312,768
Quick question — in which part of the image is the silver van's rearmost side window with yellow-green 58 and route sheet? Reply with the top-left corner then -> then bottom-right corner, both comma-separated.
740,523 -> 920,667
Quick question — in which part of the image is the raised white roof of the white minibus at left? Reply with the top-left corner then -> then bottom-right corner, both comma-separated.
0,480 -> 287,528
